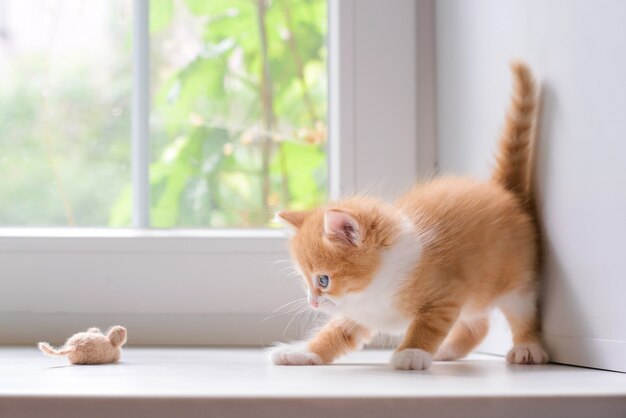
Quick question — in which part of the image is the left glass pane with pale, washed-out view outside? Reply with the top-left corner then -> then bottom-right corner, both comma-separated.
0,0 -> 132,226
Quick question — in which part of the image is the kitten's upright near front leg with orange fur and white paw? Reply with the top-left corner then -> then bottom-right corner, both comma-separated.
391,304 -> 460,370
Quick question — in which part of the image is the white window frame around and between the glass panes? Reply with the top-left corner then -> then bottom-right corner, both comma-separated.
0,0 -> 435,345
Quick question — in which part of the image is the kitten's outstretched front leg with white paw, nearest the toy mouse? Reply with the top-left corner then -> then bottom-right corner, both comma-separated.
270,318 -> 370,365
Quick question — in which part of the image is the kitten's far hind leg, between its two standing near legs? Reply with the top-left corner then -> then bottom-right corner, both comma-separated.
435,316 -> 489,361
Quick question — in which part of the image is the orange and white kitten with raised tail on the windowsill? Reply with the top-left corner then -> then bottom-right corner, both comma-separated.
270,63 -> 548,370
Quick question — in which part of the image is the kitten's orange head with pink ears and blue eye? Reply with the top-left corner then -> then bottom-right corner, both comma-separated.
278,197 -> 401,313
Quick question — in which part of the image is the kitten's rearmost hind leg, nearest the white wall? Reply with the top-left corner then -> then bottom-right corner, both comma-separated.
497,288 -> 548,364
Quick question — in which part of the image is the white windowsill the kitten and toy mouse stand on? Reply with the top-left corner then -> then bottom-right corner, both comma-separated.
0,347 -> 626,418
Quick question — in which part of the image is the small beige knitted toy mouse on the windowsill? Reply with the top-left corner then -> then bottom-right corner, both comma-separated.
39,326 -> 126,364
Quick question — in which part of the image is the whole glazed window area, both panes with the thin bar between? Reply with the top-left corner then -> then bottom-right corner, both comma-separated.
0,0 -> 327,228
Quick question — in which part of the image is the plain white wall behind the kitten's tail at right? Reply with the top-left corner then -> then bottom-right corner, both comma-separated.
436,0 -> 626,371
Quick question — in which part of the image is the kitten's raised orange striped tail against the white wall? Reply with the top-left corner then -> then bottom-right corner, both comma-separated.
491,62 -> 537,205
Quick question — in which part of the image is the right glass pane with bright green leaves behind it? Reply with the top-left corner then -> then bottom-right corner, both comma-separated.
150,0 -> 327,228
